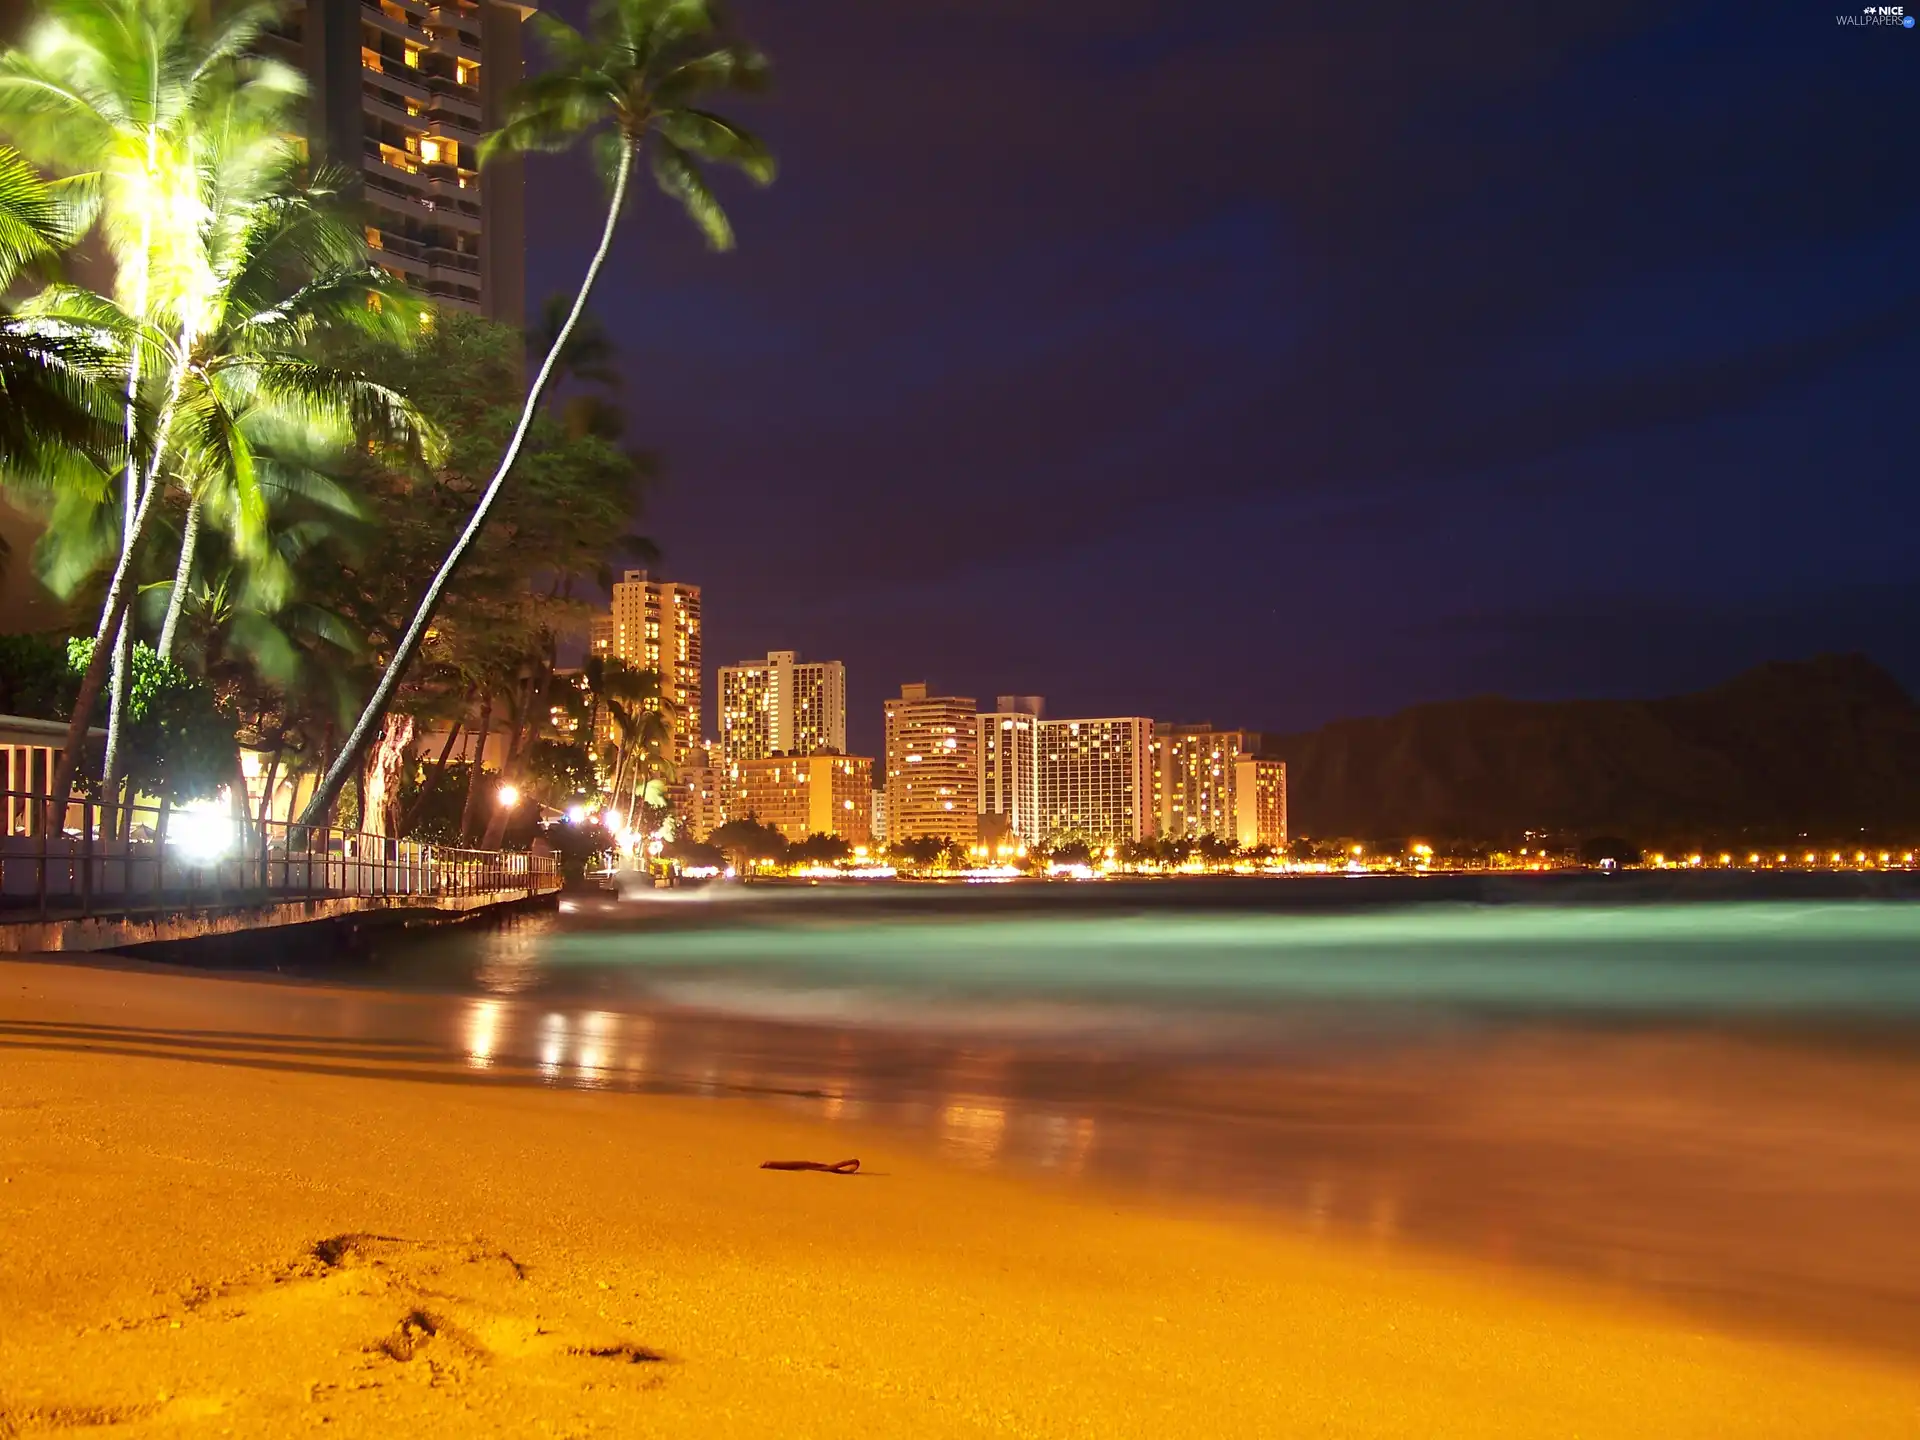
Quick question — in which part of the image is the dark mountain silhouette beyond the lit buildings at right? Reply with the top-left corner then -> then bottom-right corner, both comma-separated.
1271,655 -> 1920,841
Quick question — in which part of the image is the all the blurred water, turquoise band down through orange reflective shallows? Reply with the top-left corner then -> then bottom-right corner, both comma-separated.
322,899 -> 1920,1356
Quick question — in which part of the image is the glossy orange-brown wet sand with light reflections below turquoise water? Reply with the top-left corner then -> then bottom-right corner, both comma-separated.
408,1000 -> 1920,1356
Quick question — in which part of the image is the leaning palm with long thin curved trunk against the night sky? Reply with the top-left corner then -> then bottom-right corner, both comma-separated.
303,0 -> 774,824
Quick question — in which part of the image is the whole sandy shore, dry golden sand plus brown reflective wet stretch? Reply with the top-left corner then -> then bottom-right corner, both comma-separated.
0,962 -> 1920,1436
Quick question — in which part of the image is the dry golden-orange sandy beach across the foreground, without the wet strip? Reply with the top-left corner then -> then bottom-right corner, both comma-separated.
0,962 -> 1920,1436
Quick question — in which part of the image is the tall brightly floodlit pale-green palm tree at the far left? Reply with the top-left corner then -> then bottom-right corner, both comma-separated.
0,0 -> 305,818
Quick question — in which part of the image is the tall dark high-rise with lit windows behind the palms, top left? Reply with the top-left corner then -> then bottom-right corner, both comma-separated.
267,0 -> 536,324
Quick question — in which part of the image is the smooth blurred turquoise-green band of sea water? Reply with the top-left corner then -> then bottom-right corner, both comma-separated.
499,900 -> 1920,1023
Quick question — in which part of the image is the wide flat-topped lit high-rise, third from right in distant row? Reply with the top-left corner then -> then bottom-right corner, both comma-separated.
1037,714 -> 1154,845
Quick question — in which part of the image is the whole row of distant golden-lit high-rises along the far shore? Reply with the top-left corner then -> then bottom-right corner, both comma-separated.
588,587 -> 1288,849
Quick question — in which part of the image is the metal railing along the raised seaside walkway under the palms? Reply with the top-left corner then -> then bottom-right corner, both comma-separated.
0,789 -> 561,922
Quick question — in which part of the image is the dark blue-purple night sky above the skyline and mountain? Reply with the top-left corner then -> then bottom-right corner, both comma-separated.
528,0 -> 1920,753
